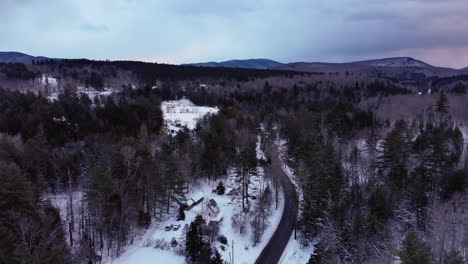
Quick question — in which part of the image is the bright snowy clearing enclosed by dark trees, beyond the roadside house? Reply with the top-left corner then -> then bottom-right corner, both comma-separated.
161,99 -> 218,134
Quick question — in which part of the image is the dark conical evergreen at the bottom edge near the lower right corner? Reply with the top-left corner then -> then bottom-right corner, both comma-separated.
398,231 -> 433,264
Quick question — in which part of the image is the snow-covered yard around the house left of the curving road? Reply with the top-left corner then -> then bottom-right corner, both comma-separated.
103,134 -> 284,264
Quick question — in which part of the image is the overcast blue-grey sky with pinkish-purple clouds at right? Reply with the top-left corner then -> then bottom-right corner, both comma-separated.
0,0 -> 468,68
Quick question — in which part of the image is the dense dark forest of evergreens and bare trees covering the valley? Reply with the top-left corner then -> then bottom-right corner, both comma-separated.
0,60 -> 468,264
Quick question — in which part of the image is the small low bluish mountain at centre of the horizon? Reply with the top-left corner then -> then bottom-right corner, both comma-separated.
184,59 -> 283,69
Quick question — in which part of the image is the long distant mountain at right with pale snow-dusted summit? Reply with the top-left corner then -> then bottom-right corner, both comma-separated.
275,57 -> 460,79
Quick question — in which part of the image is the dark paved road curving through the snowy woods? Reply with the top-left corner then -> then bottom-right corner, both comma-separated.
255,147 -> 298,264
